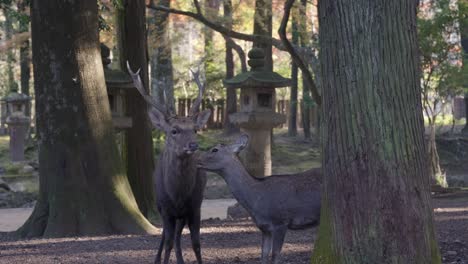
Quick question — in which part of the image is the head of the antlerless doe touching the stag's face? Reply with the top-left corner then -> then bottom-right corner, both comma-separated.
197,134 -> 249,171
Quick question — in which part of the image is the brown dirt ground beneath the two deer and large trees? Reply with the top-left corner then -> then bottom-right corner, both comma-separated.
0,194 -> 468,264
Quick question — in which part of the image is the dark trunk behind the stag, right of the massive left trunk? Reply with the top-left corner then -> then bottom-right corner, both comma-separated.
119,0 -> 157,217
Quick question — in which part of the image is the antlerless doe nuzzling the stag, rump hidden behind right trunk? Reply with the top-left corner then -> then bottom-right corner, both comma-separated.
197,135 -> 321,264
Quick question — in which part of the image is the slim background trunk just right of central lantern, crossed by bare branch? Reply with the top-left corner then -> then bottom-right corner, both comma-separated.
288,7 -> 299,137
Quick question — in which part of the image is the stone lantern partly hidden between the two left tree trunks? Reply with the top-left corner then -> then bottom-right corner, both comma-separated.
101,44 -> 134,130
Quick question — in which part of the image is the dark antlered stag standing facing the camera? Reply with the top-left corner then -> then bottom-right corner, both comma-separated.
127,62 -> 211,264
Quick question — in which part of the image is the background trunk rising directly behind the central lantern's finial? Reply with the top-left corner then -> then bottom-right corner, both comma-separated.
252,0 -> 273,71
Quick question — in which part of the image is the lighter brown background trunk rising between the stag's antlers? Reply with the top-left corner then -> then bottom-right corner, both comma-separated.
148,0 -> 175,114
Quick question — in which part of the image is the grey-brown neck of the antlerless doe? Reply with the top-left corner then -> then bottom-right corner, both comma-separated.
221,159 -> 259,212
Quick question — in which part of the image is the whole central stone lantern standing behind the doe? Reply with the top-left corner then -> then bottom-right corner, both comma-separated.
224,48 -> 291,177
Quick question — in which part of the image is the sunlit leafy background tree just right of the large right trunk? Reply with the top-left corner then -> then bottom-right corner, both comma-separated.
418,0 -> 463,187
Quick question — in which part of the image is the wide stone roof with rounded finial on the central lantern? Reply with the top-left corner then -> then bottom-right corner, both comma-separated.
224,48 -> 291,88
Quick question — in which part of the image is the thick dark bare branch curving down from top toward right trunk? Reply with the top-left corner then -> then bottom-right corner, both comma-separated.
278,0 -> 322,105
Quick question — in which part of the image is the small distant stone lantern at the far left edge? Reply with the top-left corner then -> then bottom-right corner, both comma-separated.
2,89 -> 31,161
